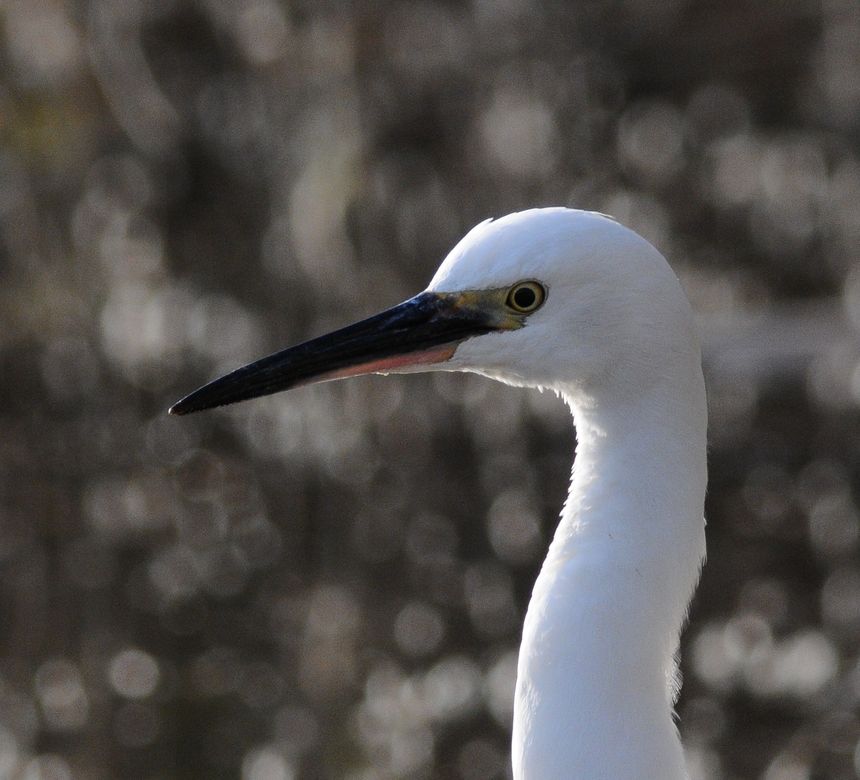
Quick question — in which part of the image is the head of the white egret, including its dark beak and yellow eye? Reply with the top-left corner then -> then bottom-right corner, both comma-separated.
171,208 -> 698,414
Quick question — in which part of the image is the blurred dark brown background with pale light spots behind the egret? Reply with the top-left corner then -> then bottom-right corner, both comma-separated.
0,0 -> 860,780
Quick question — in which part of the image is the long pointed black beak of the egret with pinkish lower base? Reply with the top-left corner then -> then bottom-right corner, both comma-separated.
170,292 -> 498,414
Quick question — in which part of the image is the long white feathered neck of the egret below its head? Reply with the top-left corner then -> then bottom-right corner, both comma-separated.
513,362 -> 707,780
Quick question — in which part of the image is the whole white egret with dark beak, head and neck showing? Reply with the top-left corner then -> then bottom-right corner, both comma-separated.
171,208 -> 707,780
